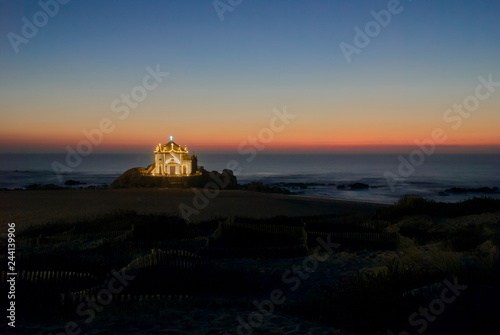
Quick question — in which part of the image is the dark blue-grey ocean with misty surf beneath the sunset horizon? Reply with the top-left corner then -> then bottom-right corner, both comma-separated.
0,152 -> 500,203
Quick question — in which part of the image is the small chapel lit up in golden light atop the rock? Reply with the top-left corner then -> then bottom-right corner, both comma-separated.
148,136 -> 198,177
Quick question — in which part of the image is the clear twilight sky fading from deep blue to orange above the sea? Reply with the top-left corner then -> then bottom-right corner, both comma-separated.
0,0 -> 500,153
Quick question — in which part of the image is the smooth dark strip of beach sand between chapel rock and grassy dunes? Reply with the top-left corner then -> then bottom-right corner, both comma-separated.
0,189 -> 382,229
